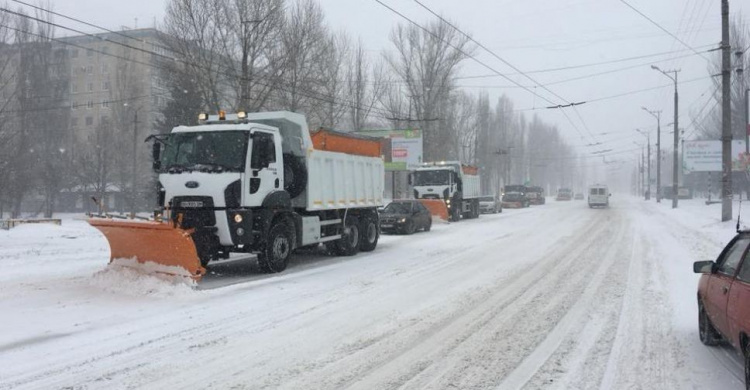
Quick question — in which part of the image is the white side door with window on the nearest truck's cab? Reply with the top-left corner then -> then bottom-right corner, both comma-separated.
245,130 -> 284,207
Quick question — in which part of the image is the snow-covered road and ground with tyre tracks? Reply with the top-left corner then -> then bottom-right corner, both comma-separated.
0,200 -> 750,389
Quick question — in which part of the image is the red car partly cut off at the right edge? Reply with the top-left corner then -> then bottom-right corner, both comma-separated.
693,231 -> 750,389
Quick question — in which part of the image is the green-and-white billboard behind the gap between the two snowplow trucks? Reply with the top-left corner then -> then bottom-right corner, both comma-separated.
357,130 -> 423,171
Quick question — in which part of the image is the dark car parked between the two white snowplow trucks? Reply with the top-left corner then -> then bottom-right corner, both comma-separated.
380,200 -> 432,234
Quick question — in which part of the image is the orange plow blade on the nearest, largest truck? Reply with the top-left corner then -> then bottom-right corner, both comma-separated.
88,218 -> 206,282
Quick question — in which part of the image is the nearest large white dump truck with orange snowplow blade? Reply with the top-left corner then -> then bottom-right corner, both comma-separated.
89,112 -> 384,280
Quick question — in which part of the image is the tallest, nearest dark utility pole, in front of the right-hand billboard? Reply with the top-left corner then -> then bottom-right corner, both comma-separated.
721,0 -> 732,222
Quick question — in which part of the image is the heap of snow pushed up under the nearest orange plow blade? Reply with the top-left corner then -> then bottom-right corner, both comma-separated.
91,259 -> 198,298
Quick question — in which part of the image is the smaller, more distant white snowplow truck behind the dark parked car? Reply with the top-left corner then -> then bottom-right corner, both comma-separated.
410,161 -> 482,222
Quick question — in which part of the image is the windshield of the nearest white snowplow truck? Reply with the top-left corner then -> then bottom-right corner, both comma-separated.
161,131 -> 248,172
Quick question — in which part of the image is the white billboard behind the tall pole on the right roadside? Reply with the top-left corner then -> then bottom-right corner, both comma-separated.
683,140 -> 748,173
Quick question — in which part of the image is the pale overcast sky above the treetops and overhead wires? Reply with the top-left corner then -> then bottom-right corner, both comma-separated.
52,0 -> 750,166
